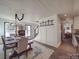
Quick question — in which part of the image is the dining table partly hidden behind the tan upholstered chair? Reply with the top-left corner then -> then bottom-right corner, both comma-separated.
5,37 -> 33,50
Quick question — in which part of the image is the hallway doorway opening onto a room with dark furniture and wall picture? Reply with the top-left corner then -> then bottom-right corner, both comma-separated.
61,18 -> 72,43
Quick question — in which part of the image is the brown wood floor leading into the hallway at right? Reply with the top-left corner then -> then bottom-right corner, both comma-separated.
49,39 -> 76,59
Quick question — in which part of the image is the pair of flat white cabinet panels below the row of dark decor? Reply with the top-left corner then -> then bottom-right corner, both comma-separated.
39,25 -> 57,46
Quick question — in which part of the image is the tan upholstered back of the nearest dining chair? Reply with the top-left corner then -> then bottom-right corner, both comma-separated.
15,37 -> 28,53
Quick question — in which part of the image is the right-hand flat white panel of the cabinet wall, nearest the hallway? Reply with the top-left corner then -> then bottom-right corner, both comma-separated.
46,26 -> 57,46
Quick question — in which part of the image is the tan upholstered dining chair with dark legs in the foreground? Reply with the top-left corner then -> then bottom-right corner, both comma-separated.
9,37 -> 28,59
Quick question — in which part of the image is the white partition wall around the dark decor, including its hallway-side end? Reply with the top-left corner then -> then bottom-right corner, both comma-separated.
35,15 -> 61,47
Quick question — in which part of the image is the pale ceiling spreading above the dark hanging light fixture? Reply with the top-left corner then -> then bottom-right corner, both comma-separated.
0,0 -> 79,21
